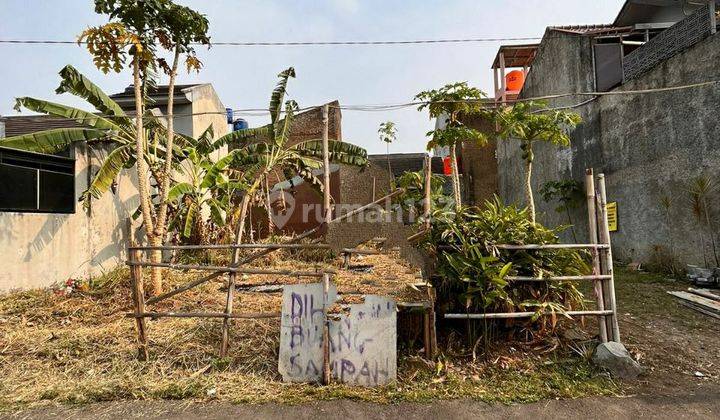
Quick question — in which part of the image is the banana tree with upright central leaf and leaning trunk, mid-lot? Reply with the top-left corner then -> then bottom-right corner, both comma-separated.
204,67 -> 368,243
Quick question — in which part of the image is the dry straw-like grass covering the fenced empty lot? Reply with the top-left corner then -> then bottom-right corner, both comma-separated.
0,246 -> 618,409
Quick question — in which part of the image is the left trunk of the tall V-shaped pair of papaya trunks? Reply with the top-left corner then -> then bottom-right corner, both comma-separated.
133,55 -> 157,293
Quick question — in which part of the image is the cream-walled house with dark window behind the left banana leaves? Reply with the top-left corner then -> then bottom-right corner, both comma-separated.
0,85 -> 228,291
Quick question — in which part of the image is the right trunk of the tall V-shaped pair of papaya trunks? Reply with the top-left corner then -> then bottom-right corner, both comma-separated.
150,47 -> 180,296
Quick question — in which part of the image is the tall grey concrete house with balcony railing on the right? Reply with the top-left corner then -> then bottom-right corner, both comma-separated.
466,0 -> 720,263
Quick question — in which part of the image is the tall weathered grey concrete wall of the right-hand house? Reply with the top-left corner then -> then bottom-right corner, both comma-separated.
498,33 -> 720,263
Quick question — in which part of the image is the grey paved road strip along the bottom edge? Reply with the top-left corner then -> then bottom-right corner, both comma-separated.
6,387 -> 720,420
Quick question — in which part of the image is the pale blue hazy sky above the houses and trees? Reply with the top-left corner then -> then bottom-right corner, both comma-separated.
0,0 -> 623,153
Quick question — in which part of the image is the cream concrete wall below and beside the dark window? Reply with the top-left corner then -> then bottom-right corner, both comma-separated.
0,146 -> 139,291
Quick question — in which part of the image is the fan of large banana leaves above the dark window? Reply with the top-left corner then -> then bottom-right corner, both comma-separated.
0,66 -> 185,207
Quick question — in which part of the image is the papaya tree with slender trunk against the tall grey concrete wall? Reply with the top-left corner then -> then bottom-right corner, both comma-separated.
497,102 -> 581,223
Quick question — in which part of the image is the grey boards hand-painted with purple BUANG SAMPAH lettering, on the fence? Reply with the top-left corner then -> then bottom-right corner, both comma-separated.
278,283 -> 397,386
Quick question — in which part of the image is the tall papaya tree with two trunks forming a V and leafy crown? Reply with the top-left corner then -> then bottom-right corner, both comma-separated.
78,0 -> 210,295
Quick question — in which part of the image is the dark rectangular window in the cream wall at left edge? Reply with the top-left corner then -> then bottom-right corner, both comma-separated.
0,148 -> 75,213
